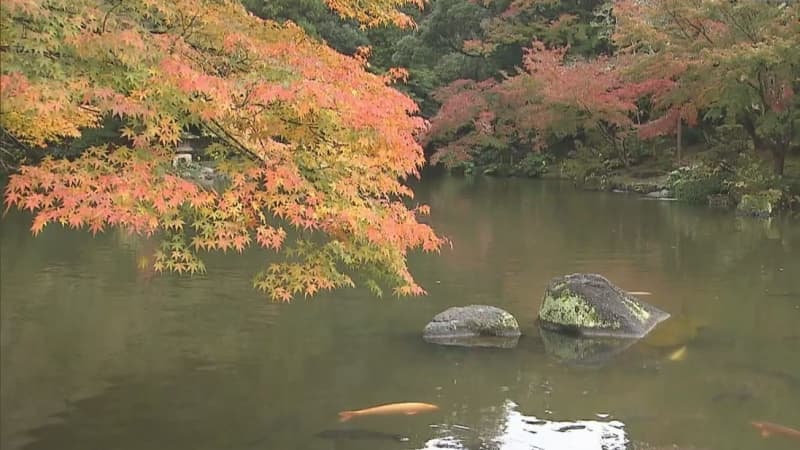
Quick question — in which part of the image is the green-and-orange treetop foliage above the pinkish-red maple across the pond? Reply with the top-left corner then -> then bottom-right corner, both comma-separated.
382,0 -> 611,117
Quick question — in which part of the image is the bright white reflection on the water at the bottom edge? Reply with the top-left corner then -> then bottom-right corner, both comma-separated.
420,400 -> 629,450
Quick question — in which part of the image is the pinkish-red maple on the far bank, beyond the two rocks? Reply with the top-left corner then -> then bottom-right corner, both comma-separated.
427,41 -> 638,170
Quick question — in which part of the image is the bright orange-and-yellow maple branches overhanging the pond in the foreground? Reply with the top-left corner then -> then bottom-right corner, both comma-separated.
0,0 -> 444,300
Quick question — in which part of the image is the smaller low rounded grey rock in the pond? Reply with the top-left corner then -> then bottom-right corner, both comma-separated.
422,305 -> 520,348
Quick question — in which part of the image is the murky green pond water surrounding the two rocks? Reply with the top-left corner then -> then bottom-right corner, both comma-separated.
0,176 -> 800,450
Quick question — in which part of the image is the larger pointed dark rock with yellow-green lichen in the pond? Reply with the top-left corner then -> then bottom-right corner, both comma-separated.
539,273 -> 669,338
